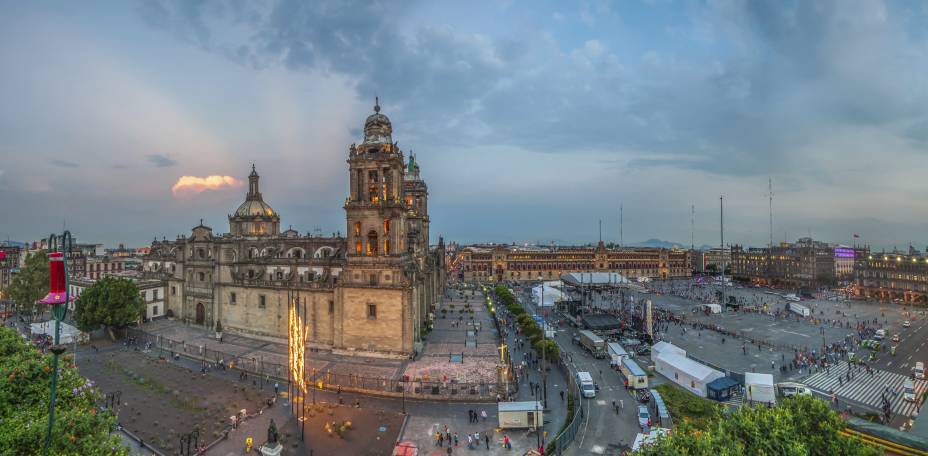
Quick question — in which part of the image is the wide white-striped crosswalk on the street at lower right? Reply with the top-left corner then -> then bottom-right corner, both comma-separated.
802,363 -> 928,416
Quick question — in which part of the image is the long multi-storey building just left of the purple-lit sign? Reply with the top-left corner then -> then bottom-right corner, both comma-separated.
731,238 -> 836,289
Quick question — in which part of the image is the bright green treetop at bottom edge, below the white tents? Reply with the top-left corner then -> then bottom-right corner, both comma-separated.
637,396 -> 881,456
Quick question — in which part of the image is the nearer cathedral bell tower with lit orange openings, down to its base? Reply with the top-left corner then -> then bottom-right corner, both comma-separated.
334,100 -> 416,357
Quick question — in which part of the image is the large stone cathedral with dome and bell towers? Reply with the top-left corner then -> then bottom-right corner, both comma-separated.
143,101 -> 446,357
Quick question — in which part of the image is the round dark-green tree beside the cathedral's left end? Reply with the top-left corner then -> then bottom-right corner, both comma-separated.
74,277 -> 145,340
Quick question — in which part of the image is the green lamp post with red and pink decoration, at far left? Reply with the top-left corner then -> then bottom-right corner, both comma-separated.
39,231 -> 74,456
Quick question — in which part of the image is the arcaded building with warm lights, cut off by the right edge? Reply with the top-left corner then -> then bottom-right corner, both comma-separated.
851,247 -> 928,304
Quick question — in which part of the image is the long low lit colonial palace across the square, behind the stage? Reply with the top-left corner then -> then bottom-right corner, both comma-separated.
461,241 -> 692,282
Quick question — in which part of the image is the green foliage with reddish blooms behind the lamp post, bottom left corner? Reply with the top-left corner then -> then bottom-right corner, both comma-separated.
0,328 -> 126,456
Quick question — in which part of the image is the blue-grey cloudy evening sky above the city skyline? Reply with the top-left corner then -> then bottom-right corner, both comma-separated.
0,0 -> 928,250
